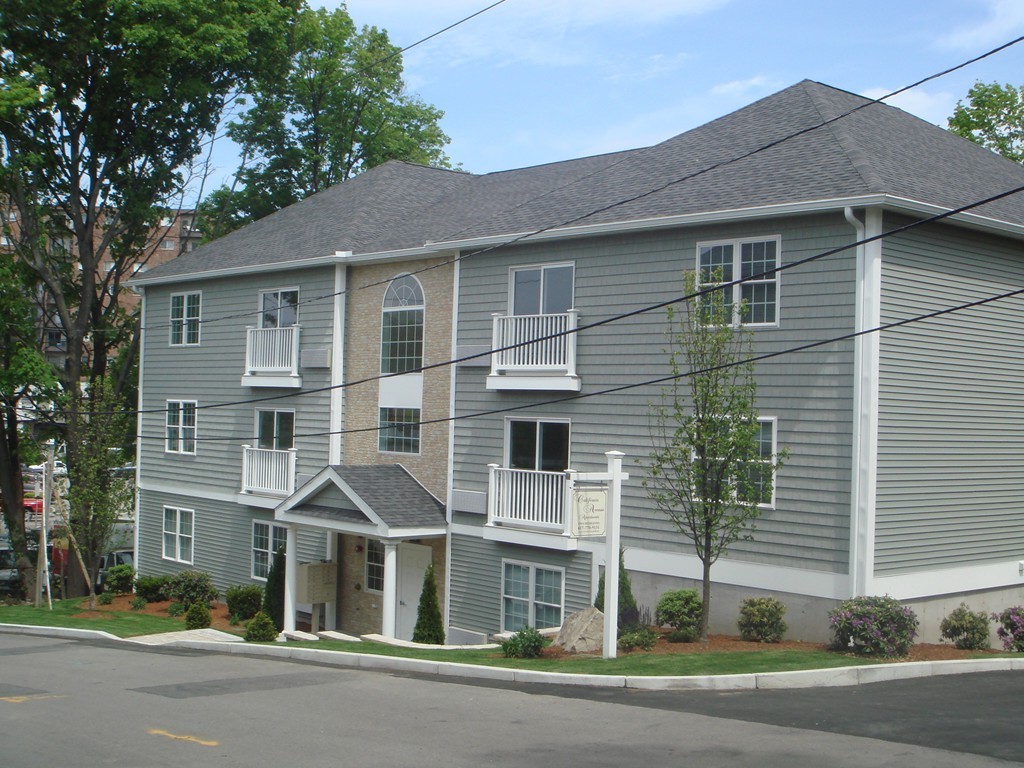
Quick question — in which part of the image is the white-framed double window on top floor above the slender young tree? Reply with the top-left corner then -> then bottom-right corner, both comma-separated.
697,236 -> 781,326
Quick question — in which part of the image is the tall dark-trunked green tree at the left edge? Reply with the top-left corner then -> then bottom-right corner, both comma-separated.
0,0 -> 298,593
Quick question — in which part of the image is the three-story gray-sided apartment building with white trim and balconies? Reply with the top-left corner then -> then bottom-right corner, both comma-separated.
136,81 -> 1024,639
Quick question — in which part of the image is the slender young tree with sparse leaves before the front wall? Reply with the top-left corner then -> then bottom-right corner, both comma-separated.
642,273 -> 784,640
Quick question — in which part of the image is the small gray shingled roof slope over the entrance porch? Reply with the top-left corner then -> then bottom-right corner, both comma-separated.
332,464 -> 445,528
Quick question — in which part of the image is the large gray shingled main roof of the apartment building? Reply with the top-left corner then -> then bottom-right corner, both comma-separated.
140,80 -> 1024,283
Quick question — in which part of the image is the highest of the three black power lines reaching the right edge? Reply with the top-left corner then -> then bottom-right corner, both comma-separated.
125,34 -> 1024,330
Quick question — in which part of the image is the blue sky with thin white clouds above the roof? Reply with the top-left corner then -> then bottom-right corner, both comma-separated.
201,0 -> 1024,188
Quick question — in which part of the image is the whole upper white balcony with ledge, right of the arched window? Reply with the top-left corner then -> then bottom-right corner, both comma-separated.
487,309 -> 581,392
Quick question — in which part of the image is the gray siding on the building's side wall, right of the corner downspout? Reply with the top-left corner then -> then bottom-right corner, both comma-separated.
874,217 -> 1024,574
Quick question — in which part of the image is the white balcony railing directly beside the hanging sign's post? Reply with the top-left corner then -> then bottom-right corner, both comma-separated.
487,464 -> 569,536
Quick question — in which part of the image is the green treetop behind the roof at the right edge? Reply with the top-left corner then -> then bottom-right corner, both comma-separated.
948,82 -> 1024,163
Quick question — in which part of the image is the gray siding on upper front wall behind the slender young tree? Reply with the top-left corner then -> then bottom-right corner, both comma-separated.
454,215 -> 855,572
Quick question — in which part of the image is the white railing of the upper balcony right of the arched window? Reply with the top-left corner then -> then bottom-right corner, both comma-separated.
490,309 -> 579,377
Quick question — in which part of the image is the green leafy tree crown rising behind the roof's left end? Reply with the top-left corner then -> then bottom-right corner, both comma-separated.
201,5 -> 450,236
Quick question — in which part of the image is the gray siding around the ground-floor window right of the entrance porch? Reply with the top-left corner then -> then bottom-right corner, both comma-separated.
449,534 -> 593,634
